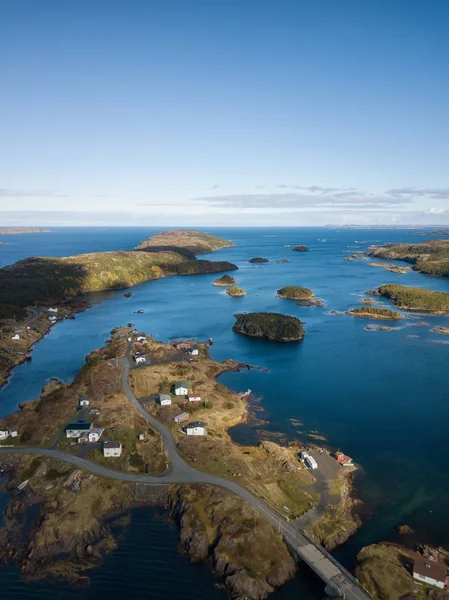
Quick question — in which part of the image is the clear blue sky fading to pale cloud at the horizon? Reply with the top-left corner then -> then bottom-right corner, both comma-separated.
0,0 -> 449,226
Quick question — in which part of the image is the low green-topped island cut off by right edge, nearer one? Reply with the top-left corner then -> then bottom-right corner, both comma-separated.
371,284 -> 449,312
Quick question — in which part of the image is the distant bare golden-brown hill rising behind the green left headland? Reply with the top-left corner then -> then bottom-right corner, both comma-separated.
137,229 -> 235,254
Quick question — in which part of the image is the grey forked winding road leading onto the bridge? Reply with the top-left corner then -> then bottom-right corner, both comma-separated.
0,355 -> 372,600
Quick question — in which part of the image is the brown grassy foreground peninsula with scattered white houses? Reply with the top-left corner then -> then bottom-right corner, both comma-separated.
0,328 -> 358,600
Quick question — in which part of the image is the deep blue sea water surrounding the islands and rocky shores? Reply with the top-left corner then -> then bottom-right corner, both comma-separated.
0,228 -> 449,598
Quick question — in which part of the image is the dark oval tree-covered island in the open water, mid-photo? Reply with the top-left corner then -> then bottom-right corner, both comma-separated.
232,312 -> 305,342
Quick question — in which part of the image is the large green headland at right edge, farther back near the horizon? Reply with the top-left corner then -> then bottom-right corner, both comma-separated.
367,240 -> 449,277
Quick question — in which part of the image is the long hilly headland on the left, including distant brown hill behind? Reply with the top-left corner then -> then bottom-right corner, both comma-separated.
0,230 -> 237,386
